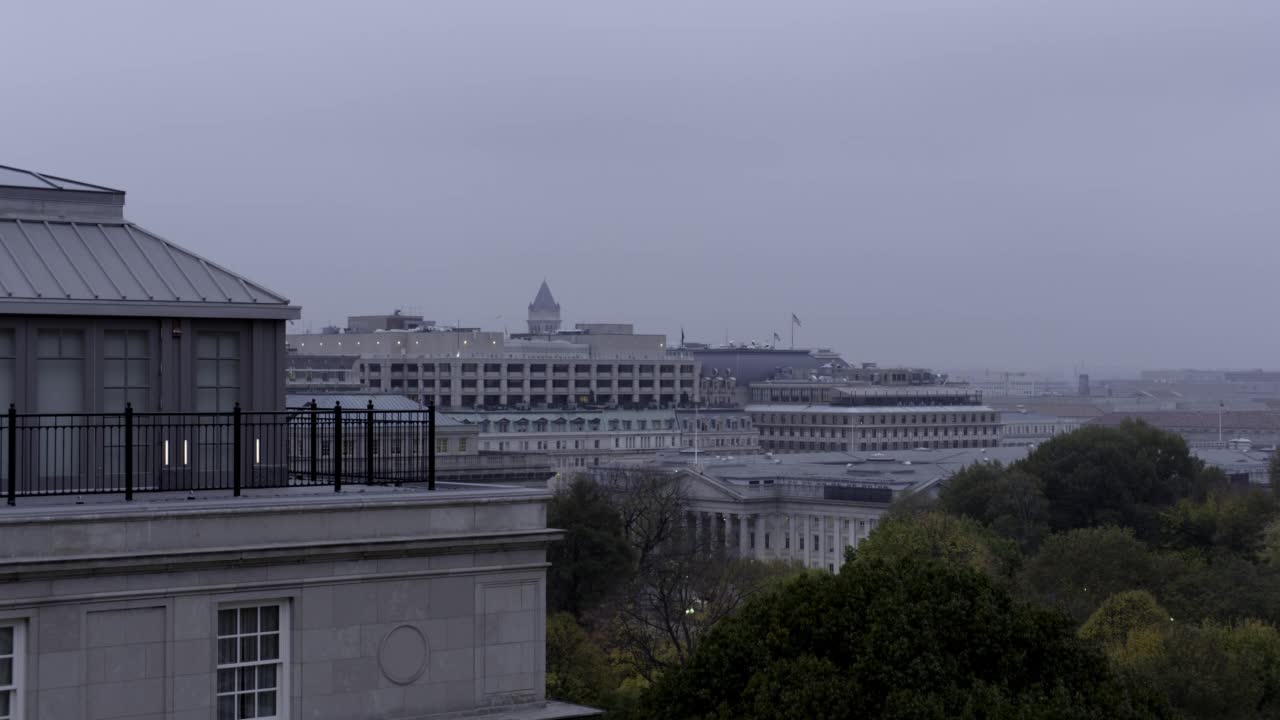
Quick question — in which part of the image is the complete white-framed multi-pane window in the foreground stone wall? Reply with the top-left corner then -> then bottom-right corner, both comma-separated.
218,605 -> 289,720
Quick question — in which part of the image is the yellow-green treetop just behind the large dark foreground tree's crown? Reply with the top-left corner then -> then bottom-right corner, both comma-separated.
852,512 -> 1018,578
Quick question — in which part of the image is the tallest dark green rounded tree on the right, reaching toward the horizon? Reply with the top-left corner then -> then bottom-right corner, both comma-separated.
1012,420 -> 1207,538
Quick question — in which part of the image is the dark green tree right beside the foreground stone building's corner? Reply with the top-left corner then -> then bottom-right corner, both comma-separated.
547,478 -> 632,618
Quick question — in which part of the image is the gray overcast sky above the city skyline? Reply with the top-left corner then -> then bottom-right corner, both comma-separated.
0,0 -> 1280,369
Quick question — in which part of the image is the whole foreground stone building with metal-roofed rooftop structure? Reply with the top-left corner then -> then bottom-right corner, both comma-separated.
0,168 -> 593,720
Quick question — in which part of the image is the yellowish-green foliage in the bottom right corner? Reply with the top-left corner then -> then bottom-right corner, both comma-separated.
1110,620 -> 1280,720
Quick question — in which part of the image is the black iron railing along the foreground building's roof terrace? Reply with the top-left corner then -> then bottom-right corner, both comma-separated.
0,405 -> 435,505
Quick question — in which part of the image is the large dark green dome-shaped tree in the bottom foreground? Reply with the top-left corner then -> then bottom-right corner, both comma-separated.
645,556 -> 1164,720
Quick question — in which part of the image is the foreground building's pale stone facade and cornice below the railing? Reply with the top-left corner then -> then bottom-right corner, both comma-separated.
0,488 -> 581,720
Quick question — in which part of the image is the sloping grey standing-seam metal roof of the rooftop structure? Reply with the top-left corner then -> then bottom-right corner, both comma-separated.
0,215 -> 300,319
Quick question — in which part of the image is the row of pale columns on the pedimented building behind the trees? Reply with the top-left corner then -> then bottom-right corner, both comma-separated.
685,510 -> 876,570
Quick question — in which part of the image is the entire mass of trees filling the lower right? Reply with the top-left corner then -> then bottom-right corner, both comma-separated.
548,421 -> 1280,720
